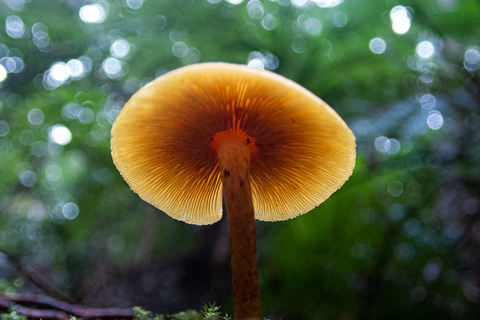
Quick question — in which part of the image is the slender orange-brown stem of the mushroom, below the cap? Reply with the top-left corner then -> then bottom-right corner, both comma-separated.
217,140 -> 262,319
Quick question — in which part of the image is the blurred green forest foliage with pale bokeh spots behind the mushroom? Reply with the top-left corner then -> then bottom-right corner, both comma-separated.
0,0 -> 480,319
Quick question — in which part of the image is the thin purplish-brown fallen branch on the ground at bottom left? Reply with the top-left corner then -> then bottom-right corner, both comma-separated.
0,293 -> 134,320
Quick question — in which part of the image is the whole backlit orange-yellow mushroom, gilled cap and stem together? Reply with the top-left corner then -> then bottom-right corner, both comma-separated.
111,62 -> 355,319
